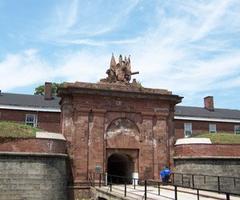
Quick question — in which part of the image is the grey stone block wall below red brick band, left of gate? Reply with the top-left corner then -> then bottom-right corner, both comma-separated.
0,153 -> 67,200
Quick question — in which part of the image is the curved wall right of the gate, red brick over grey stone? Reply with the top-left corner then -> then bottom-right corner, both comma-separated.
174,144 -> 240,194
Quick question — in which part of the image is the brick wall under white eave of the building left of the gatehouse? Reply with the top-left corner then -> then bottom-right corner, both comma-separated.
0,109 -> 60,133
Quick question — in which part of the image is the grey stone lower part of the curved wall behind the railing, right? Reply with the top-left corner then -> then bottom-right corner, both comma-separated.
174,158 -> 240,194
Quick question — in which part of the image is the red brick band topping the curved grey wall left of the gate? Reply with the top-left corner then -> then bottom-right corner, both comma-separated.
0,138 -> 66,154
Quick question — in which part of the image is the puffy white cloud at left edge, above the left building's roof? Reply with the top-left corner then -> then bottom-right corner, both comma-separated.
0,49 -> 54,91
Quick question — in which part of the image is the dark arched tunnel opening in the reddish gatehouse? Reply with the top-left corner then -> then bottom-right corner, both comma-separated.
107,153 -> 134,184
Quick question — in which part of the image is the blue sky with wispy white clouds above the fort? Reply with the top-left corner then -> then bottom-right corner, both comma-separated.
0,0 -> 240,109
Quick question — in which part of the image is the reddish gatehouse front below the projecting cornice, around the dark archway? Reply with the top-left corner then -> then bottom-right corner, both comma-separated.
62,91 -> 174,184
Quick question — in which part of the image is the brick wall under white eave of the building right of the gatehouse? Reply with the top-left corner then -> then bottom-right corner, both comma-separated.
174,119 -> 237,139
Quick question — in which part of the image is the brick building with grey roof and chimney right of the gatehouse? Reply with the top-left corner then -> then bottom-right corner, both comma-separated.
174,96 -> 240,138
